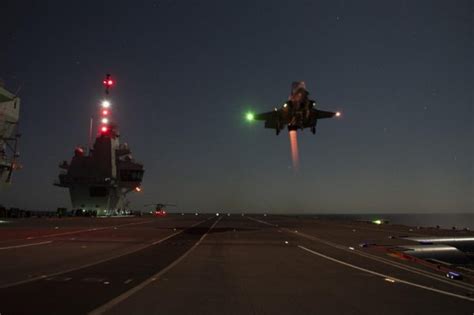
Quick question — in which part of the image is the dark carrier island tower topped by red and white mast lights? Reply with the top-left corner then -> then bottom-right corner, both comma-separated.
55,75 -> 144,216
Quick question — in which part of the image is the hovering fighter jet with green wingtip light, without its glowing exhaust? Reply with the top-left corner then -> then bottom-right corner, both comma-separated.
247,81 -> 341,135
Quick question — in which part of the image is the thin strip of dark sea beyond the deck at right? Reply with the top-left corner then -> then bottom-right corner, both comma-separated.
314,213 -> 474,230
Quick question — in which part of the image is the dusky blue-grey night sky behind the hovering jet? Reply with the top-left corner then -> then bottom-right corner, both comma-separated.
0,0 -> 474,213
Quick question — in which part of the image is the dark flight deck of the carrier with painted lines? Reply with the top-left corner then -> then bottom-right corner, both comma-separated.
0,214 -> 474,315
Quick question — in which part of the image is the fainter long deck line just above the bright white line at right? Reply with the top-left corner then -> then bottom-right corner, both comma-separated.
248,217 -> 474,290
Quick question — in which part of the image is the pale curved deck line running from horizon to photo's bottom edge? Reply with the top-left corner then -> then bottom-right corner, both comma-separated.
88,217 -> 222,315
